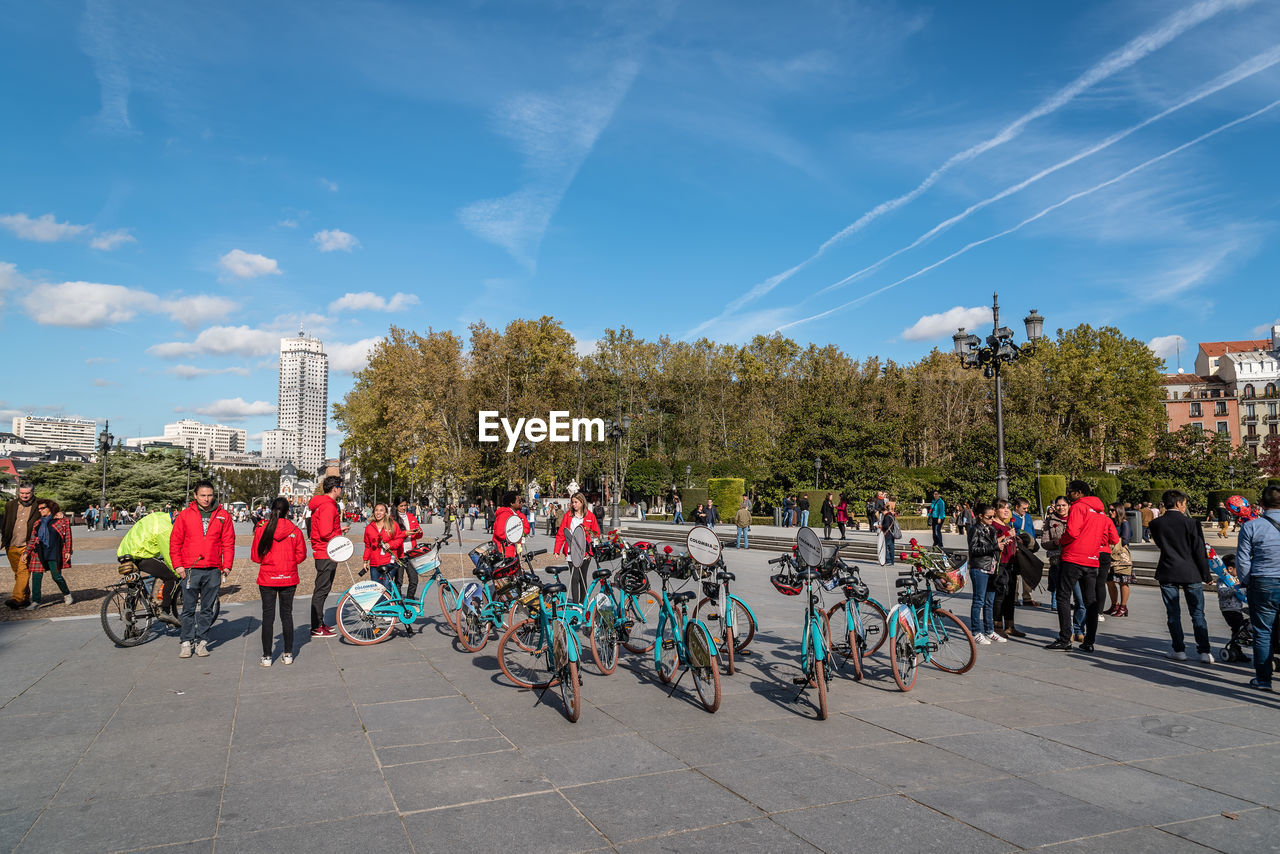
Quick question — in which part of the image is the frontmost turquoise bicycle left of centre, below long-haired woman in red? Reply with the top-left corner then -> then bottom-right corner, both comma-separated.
498,566 -> 582,721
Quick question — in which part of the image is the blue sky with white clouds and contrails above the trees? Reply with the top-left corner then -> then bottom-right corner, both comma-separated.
0,0 -> 1280,452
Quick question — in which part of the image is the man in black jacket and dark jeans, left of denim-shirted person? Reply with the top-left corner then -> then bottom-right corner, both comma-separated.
1151,489 -> 1213,665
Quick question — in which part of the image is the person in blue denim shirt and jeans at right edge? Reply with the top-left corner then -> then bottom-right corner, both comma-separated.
1235,487 -> 1280,691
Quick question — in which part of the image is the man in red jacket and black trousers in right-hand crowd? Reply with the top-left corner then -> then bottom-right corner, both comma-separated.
1044,480 -> 1120,653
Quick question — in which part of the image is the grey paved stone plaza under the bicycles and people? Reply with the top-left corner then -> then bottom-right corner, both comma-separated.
0,538 -> 1280,854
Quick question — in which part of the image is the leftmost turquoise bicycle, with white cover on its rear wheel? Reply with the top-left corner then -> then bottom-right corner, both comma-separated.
338,534 -> 458,647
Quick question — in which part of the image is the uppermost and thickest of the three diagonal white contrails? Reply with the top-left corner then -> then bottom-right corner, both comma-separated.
685,0 -> 1257,338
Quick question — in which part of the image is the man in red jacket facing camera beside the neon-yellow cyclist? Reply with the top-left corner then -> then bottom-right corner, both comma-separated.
169,480 -> 236,658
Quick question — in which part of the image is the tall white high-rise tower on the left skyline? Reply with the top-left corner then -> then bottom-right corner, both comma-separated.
270,332 -> 329,474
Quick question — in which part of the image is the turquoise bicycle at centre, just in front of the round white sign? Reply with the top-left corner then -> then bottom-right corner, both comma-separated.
653,547 -> 721,712
